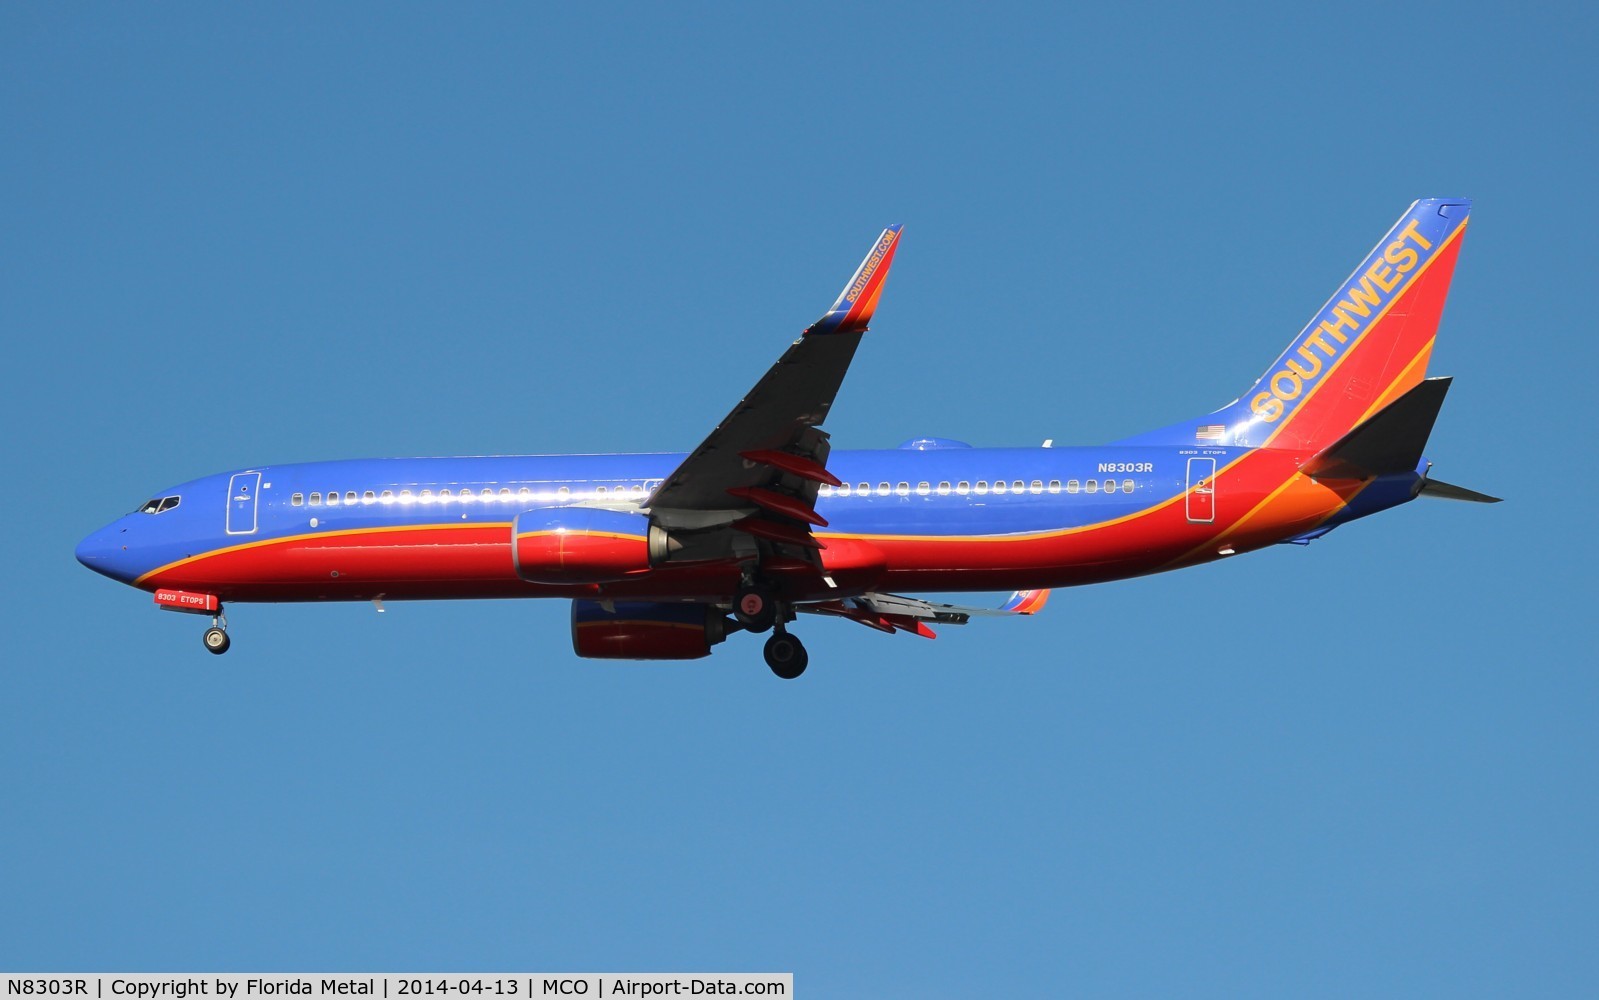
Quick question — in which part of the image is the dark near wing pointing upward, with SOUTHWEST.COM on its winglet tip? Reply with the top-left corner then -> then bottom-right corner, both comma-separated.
646,226 -> 900,537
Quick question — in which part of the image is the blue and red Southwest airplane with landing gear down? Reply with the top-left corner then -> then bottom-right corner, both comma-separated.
77,198 -> 1498,680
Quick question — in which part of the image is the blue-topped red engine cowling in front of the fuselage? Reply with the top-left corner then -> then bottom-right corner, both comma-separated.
512,507 -> 651,584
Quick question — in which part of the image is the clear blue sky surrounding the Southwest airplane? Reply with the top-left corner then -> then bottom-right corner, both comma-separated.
0,3 -> 1599,997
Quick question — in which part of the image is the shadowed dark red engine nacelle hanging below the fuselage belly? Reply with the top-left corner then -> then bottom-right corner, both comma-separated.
572,600 -> 728,659
